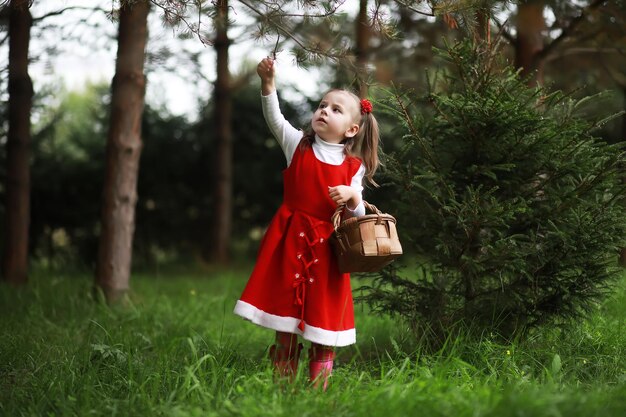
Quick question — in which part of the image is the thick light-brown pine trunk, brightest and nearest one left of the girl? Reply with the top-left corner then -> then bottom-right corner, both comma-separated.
95,0 -> 150,302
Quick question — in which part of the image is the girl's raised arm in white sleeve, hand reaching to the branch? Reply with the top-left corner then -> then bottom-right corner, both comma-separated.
257,58 -> 303,165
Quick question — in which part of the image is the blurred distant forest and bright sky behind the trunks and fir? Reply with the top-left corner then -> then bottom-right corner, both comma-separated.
0,1 -> 626,280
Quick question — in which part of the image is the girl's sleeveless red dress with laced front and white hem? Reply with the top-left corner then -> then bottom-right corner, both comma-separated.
235,141 -> 361,346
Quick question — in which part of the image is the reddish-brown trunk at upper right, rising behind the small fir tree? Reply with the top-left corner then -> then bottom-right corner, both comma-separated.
515,0 -> 546,86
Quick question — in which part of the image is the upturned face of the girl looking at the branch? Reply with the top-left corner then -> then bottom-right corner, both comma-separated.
311,90 -> 360,143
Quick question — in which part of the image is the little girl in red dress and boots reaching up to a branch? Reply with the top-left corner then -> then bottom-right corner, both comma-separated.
235,58 -> 378,390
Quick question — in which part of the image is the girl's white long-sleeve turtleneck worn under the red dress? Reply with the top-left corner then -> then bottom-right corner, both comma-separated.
261,91 -> 365,216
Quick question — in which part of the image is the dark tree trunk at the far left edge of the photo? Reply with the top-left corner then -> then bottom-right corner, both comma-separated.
2,0 -> 33,285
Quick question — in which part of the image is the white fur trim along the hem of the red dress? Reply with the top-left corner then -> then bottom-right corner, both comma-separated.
234,300 -> 356,346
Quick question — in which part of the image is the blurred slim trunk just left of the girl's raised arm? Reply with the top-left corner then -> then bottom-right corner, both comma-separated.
208,0 -> 233,263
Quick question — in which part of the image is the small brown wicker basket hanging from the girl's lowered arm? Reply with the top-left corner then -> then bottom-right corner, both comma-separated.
331,201 -> 402,272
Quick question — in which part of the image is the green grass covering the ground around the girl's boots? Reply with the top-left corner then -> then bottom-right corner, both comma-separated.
0,270 -> 626,417
